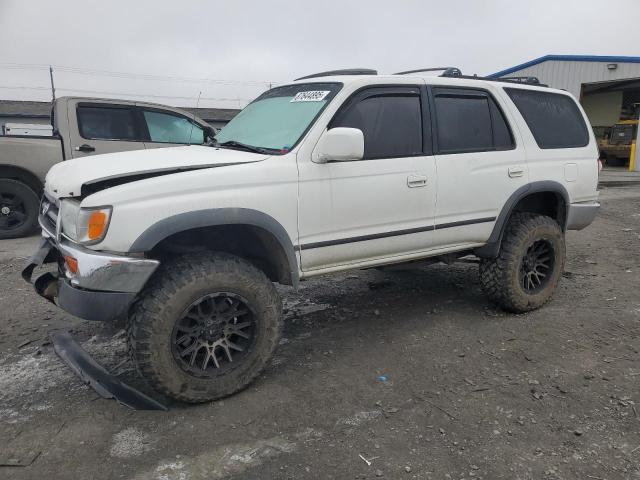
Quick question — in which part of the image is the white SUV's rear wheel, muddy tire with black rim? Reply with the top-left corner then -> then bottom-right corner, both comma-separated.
480,213 -> 565,313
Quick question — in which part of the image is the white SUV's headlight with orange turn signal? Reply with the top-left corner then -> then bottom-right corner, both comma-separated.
60,200 -> 111,245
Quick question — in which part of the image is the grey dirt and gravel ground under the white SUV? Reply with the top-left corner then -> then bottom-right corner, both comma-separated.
0,186 -> 640,480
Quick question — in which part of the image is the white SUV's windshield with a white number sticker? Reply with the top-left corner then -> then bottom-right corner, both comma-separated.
216,83 -> 342,154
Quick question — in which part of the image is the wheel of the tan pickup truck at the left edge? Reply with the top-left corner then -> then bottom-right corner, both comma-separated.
0,178 -> 39,239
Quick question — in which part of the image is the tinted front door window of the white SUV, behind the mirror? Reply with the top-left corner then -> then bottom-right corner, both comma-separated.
331,94 -> 422,159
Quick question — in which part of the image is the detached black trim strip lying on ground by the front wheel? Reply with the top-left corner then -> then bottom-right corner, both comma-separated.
49,331 -> 168,411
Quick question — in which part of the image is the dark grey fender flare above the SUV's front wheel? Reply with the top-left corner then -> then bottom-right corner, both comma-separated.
129,208 -> 300,288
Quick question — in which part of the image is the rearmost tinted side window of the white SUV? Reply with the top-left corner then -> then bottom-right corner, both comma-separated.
505,88 -> 589,149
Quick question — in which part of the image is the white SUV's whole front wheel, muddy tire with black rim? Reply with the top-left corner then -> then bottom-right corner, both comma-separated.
128,252 -> 282,403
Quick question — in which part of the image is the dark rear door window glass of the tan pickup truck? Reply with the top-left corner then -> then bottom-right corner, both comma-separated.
78,106 -> 137,141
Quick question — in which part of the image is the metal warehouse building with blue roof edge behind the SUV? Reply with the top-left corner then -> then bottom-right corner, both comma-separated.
489,55 -> 640,169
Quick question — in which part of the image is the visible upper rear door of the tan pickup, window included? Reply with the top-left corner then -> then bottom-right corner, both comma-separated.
68,101 -> 145,158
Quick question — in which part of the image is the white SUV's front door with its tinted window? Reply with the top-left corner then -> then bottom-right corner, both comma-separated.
298,86 -> 436,274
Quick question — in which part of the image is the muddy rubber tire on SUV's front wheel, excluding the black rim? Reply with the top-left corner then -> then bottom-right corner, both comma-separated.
127,252 -> 283,403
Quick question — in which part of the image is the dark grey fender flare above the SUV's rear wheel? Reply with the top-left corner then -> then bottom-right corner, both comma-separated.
474,180 -> 570,258
